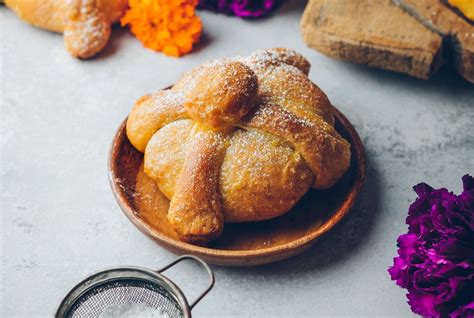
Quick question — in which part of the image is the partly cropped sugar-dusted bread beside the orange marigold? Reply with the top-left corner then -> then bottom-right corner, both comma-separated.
5,0 -> 128,59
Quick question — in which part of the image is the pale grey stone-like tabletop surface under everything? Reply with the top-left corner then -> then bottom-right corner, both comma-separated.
0,1 -> 474,317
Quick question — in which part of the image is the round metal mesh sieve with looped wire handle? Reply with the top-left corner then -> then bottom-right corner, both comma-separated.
56,255 -> 214,318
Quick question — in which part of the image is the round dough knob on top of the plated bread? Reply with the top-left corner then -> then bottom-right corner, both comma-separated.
181,60 -> 257,130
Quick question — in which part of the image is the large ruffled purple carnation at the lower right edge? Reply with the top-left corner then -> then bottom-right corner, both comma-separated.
388,175 -> 474,318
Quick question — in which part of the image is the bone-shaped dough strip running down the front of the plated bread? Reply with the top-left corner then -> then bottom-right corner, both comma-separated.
168,126 -> 227,244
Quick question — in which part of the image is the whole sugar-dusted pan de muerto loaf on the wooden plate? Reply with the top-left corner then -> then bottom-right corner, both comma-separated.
127,49 -> 351,244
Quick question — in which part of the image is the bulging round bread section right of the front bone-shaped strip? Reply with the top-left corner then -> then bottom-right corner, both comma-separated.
219,129 -> 313,222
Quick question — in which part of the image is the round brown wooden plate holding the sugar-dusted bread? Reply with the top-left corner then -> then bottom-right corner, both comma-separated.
108,106 -> 365,266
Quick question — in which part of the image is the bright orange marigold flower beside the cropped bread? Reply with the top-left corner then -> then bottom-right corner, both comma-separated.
120,0 -> 202,56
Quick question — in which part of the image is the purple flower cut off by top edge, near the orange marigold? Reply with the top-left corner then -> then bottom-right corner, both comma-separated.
198,0 -> 282,18
